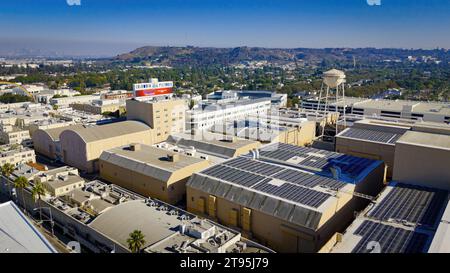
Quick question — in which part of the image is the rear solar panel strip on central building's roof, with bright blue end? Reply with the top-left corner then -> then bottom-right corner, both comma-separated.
260,143 -> 374,178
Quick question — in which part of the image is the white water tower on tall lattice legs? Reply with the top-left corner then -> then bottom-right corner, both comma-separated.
317,69 -> 346,139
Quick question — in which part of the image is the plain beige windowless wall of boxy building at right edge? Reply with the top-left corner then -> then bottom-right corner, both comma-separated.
393,142 -> 450,190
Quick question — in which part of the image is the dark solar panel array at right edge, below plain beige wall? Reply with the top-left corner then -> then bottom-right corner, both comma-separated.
368,184 -> 447,227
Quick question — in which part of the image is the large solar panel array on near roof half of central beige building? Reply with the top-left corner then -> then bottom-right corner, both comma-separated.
202,157 -> 345,208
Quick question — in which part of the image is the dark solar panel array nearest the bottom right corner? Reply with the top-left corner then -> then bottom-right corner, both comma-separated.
352,220 -> 429,253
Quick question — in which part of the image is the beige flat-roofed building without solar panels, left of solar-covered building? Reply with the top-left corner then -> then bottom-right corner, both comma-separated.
99,144 -> 209,204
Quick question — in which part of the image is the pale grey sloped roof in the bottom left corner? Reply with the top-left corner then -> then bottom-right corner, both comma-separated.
0,201 -> 57,253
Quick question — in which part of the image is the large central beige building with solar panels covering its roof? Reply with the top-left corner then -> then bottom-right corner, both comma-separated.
187,144 -> 384,252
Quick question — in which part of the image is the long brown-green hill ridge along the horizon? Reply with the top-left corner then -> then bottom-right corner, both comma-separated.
113,46 -> 450,67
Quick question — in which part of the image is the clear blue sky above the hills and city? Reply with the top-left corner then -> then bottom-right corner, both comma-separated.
0,0 -> 450,55
